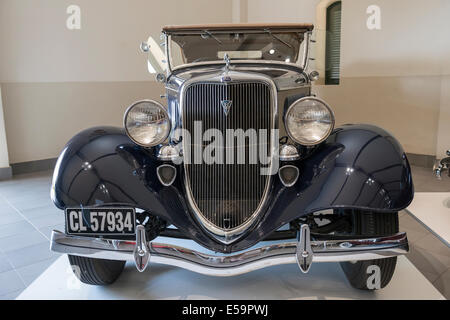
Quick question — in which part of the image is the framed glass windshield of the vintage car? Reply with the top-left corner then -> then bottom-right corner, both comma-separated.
169,30 -> 304,67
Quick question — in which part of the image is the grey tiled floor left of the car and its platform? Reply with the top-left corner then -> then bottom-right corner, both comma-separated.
0,172 -> 64,299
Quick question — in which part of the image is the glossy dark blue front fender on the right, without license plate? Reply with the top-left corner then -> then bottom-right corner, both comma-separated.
233,124 -> 414,251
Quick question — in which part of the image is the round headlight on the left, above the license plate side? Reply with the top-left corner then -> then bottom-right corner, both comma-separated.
124,100 -> 170,147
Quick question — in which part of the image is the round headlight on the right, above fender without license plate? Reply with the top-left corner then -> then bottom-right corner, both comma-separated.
284,97 -> 334,146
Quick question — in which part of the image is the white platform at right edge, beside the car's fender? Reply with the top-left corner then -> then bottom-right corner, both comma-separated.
406,192 -> 450,247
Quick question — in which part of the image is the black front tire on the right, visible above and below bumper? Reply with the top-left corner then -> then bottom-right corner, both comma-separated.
341,210 -> 398,290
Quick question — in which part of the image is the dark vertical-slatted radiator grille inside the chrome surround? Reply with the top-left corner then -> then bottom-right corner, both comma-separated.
183,82 -> 274,233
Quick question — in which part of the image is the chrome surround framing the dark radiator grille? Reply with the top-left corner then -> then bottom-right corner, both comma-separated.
178,71 -> 278,244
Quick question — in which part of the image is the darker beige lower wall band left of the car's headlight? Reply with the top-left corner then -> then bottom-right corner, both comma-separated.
2,81 -> 163,163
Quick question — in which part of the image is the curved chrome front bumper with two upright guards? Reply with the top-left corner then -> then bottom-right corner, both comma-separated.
50,225 -> 409,276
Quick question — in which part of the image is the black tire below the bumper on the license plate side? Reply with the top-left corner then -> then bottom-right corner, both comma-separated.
69,255 -> 125,286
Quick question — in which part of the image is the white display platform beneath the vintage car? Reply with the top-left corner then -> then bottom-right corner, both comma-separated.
17,238 -> 444,300
